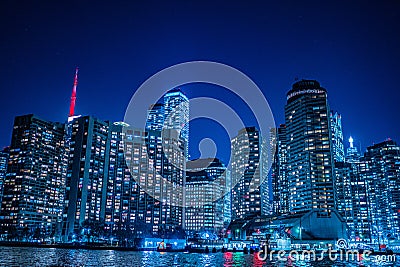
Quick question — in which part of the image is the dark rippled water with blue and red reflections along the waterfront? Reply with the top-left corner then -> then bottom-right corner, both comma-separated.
0,247 -> 400,267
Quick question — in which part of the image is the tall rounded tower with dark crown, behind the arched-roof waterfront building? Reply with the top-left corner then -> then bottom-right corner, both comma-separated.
285,80 -> 335,216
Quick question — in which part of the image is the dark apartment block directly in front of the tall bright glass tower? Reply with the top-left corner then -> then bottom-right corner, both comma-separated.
145,130 -> 186,232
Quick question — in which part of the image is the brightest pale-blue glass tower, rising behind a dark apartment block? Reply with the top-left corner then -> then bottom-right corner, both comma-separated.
164,89 -> 189,159
